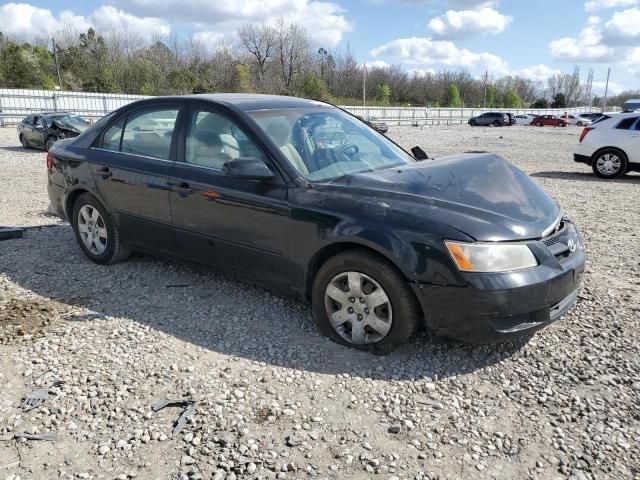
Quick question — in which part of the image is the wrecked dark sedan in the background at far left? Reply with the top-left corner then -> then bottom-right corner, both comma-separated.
17,112 -> 91,151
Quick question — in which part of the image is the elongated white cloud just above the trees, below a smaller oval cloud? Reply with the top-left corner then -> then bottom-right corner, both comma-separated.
369,37 -> 508,76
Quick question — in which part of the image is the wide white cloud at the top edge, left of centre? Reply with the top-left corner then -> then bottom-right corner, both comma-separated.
116,0 -> 353,47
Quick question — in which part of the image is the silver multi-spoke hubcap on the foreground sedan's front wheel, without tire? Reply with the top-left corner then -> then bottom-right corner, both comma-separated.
324,272 -> 393,345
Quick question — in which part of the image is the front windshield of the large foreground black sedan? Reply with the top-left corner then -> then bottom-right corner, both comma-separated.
247,105 -> 415,182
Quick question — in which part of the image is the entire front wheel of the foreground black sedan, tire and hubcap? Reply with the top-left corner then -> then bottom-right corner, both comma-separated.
311,249 -> 421,353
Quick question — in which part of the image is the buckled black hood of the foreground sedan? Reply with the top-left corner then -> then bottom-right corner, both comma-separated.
320,153 -> 561,241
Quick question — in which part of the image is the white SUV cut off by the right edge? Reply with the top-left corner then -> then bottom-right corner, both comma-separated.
573,112 -> 640,178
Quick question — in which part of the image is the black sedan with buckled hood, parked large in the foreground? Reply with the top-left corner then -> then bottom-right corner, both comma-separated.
47,94 -> 585,351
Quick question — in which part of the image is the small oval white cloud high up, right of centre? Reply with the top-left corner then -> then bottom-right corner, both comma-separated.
427,7 -> 513,39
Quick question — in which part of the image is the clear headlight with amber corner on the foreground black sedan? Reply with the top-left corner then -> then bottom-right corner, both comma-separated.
444,241 -> 538,272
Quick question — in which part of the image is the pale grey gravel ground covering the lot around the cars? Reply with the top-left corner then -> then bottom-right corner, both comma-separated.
0,126 -> 640,480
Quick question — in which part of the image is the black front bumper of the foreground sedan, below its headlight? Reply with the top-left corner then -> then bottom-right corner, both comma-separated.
412,231 -> 585,344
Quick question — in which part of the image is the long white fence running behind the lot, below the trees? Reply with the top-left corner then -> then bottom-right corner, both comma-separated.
0,89 -> 600,126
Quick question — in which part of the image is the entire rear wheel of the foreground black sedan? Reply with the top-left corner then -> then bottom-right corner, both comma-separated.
71,193 -> 131,264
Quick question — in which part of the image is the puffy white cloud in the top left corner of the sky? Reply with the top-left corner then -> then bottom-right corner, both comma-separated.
0,3 -> 171,40
